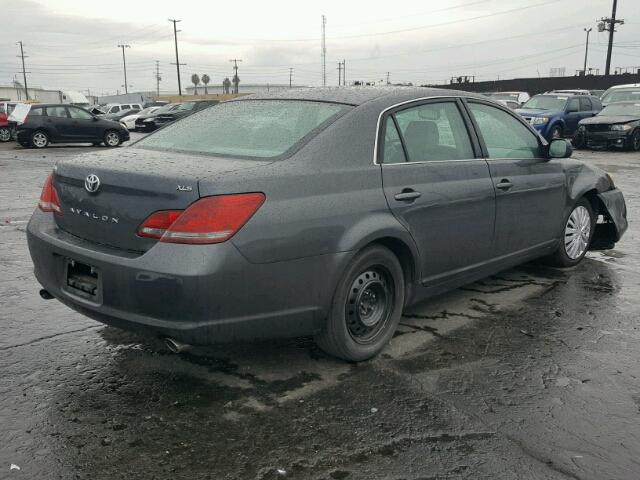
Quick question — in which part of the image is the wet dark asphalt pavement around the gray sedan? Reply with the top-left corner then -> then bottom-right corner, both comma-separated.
0,139 -> 640,480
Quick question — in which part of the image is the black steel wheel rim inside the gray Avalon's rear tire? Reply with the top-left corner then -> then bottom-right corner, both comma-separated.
345,266 -> 395,344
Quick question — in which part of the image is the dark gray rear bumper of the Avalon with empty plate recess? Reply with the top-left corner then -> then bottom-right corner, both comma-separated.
27,211 -> 349,344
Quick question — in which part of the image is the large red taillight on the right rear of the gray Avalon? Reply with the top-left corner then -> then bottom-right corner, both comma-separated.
138,193 -> 265,244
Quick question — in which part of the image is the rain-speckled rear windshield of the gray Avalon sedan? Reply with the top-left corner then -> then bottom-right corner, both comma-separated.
136,100 -> 350,159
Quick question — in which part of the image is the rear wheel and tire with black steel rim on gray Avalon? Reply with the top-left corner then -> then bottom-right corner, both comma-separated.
316,245 -> 405,362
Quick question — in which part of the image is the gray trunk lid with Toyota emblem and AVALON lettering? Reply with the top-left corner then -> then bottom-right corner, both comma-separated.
54,147 -> 267,252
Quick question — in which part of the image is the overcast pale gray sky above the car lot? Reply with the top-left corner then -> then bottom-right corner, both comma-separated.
0,0 -> 640,94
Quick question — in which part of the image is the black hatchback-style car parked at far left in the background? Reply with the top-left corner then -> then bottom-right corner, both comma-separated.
17,104 -> 129,148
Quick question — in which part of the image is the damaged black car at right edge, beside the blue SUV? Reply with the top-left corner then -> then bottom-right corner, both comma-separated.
573,102 -> 640,152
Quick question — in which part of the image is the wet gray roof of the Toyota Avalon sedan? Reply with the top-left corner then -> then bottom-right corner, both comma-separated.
233,87 -> 486,106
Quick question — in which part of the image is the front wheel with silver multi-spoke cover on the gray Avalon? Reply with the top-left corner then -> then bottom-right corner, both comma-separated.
547,197 -> 596,268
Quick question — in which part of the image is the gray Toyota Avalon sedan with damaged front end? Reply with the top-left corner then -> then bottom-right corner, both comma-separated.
27,88 -> 627,361
